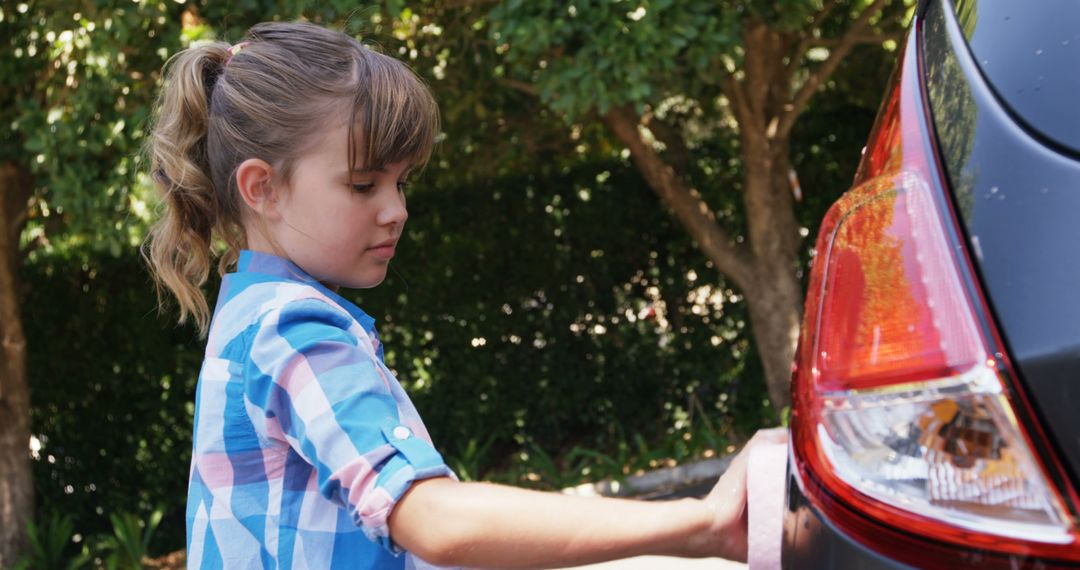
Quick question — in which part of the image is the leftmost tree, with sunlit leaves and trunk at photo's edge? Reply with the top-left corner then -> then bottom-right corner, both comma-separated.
0,1 -> 181,568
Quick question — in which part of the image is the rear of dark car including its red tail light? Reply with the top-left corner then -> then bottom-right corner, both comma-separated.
782,0 -> 1080,568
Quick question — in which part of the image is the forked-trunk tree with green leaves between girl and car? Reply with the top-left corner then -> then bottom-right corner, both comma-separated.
406,0 -> 910,412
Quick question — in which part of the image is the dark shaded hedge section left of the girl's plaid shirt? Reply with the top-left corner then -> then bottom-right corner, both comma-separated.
23,253 -> 202,545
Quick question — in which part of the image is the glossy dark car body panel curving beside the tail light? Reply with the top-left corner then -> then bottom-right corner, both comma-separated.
923,2 -> 1080,494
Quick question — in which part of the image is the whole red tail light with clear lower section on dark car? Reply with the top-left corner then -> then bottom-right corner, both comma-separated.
792,24 -> 1080,567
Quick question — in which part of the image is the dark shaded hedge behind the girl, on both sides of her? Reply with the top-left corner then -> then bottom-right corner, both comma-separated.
23,158 -> 768,552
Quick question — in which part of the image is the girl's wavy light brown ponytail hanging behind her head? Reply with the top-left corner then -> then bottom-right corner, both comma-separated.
143,42 -> 229,336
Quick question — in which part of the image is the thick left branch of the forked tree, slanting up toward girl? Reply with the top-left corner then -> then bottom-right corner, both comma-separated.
604,107 -> 754,289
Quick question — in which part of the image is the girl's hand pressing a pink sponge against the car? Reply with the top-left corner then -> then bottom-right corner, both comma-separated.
704,428 -> 787,561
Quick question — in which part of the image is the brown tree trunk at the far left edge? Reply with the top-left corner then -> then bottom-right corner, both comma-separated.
0,162 -> 33,568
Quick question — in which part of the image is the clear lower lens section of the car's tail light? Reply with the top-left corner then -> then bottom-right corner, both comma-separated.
818,368 -> 1072,544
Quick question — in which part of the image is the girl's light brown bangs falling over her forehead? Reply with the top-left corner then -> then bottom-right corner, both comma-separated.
349,48 -> 438,169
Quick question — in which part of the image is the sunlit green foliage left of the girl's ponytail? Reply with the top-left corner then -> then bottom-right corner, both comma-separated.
0,1 -> 187,255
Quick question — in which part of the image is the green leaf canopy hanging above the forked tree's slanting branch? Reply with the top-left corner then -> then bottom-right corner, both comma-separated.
489,0 -> 741,118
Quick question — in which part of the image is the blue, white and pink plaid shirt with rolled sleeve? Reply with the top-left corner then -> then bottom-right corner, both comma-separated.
187,250 -> 454,569
